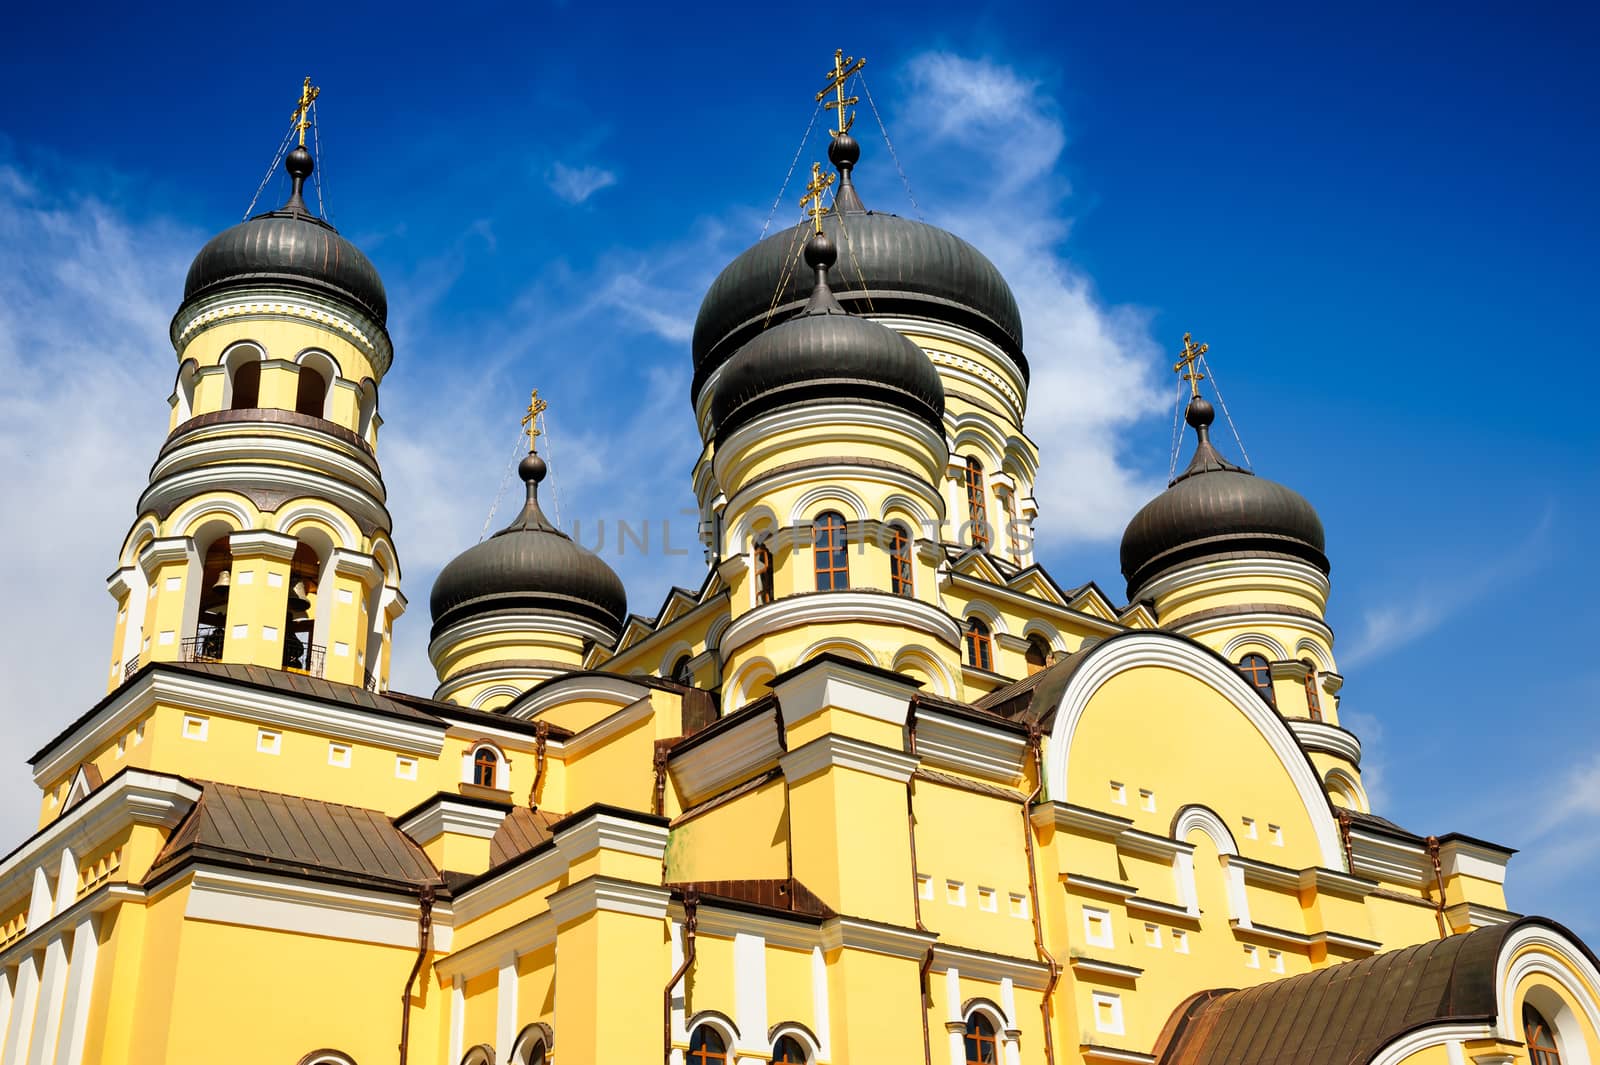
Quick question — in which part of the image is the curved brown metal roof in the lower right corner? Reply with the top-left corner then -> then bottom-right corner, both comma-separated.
1157,918 -> 1526,1065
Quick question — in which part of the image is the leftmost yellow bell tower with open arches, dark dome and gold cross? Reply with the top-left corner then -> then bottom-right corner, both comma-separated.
107,78 -> 405,688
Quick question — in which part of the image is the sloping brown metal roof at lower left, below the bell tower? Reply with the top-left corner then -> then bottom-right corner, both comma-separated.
149,780 -> 438,888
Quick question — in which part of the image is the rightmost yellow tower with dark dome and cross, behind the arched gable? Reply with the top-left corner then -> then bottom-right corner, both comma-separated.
1122,334 -> 1368,811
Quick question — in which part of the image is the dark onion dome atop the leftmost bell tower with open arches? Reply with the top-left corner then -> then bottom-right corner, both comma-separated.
184,147 -> 389,325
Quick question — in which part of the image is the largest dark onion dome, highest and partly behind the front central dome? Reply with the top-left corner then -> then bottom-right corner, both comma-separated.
691,136 -> 1027,401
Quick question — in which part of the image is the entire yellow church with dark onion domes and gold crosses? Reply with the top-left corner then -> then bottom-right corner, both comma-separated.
0,64 -> 1600,1065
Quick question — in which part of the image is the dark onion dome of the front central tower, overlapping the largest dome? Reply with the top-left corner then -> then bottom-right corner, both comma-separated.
710,235 -> 944,437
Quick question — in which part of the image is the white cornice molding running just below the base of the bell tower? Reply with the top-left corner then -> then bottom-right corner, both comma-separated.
34,668 -> 445,787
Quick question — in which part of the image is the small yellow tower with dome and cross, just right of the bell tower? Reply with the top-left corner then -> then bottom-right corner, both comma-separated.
429,392 -> 627,710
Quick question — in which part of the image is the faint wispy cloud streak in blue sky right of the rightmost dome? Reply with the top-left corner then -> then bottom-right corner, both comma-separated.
1339,504 -> 1555,668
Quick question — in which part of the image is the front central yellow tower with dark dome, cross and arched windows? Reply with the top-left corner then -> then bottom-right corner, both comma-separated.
707,209 -> 960,708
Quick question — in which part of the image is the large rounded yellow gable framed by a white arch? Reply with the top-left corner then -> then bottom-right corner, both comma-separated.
1046,632 -> 1347,870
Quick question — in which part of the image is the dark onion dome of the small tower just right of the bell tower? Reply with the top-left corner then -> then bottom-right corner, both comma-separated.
429,454 -> 627,636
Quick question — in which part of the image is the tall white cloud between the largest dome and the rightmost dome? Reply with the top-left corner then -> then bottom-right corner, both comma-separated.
899,53 -> 1165,550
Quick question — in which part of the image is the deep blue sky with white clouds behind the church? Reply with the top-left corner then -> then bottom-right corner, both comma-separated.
0,3 -> 1600,939
